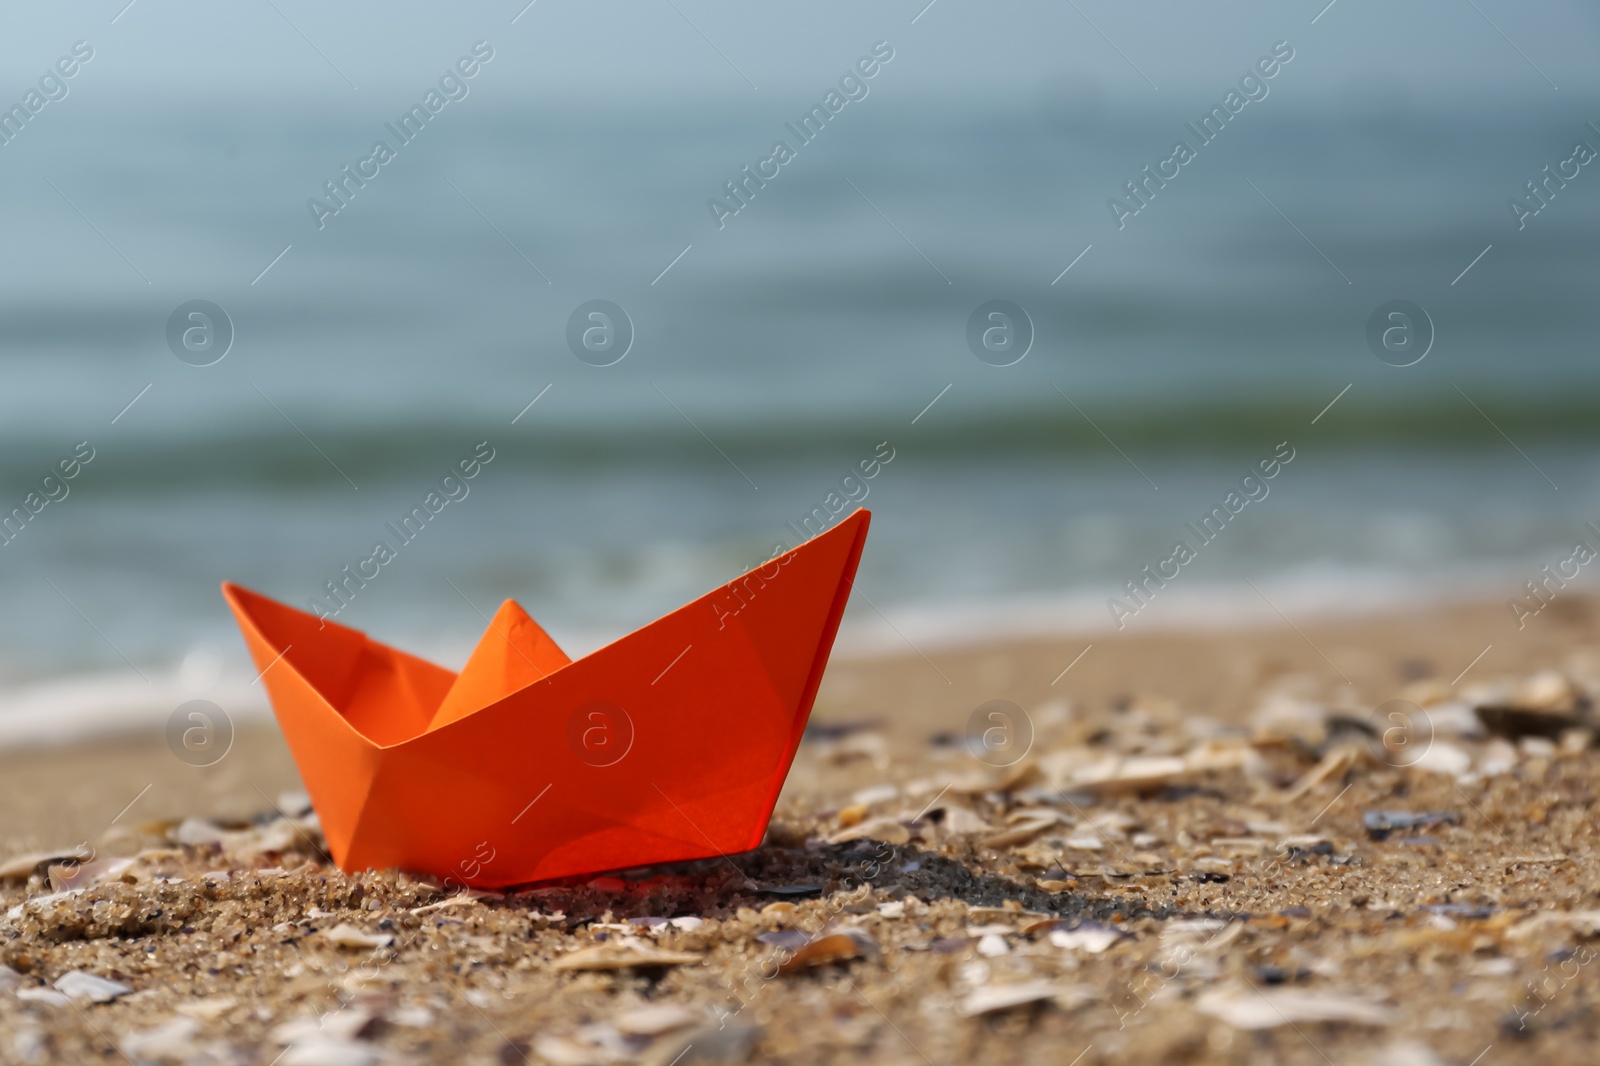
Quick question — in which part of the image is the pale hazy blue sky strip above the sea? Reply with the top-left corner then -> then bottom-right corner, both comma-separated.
0,0 -> 1600,104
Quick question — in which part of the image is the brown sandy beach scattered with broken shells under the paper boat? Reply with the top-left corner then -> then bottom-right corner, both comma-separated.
0,599 -> 1600,1066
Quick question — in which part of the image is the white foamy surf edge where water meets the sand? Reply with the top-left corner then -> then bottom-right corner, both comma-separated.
0,567 -> 1542,759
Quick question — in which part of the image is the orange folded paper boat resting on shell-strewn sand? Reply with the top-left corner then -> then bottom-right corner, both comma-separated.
222,511 -> 870,888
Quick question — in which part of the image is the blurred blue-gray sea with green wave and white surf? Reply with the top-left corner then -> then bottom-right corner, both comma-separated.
0,91 -> 1600,736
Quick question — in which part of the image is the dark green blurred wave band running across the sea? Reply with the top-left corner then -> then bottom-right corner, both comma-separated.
0,384 -> 1600,495
